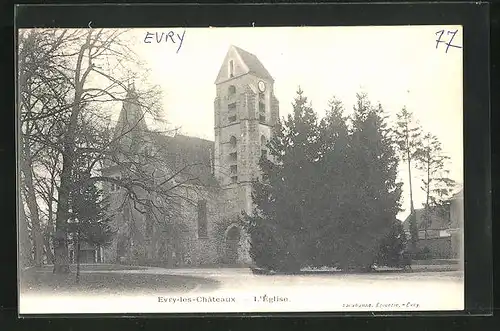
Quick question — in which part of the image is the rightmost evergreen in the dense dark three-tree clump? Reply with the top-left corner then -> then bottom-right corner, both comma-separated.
336,94 -> 402,269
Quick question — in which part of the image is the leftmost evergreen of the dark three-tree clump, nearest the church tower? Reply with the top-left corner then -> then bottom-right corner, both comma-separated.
250,88 -> 319,271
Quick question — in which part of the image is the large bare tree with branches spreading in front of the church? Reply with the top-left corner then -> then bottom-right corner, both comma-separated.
20,29 -> 211,273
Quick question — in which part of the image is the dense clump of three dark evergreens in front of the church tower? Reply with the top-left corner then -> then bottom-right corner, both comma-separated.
248,90 -> 401,271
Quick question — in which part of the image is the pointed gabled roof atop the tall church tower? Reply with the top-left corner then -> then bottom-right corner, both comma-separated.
215,45 -> 274,84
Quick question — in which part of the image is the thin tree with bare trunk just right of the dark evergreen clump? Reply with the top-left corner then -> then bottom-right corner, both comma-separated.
394,107 -> 422,252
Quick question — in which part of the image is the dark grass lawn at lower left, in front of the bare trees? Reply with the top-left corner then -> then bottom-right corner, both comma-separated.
20,264 -> 218,295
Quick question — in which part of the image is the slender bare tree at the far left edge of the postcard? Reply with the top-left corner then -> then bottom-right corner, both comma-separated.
18,30 -> 72,266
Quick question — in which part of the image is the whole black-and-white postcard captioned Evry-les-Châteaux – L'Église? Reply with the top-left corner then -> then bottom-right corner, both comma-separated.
17,25 -> 465,315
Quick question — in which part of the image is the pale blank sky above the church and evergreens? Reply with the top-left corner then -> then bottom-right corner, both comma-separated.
114,26 -> 463,219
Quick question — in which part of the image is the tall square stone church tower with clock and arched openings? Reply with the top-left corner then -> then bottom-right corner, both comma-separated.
214,46 -> 279,215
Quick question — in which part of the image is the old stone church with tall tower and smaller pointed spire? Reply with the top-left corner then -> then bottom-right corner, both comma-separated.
97,46 -> 279,266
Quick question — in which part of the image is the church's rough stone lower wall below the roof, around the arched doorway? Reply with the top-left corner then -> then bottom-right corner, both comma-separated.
103,178 -> 251,267
